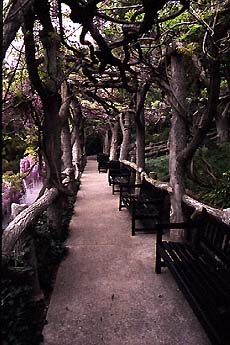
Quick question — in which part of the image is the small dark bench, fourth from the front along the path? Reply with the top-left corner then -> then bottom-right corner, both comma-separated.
108,161 -> 131,194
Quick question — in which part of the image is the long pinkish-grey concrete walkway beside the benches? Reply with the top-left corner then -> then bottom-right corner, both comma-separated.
43,160 -> 210,345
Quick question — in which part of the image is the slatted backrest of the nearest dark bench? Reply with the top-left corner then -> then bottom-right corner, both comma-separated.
196,214 -> 230,269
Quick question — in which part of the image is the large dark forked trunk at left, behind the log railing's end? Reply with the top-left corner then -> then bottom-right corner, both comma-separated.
23,0 -> 63,236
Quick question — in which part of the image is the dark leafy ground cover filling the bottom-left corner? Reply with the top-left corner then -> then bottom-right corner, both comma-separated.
1,268 -> 41,345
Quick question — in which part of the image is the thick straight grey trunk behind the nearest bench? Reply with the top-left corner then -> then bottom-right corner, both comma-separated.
169,51 -> 187,238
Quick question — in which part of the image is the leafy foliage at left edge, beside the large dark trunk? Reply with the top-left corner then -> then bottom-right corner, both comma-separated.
2,77 -> 42,173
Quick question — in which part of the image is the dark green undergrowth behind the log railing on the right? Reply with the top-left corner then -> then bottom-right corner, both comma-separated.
145,142 -> 230,208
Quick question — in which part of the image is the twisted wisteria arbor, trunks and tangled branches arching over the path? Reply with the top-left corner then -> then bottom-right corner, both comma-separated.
3,0 -> 229,239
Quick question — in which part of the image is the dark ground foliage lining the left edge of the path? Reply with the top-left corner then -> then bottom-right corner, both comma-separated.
1,188 -> 79,345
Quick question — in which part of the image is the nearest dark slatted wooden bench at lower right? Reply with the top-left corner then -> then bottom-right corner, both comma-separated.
155,212 -> 230,345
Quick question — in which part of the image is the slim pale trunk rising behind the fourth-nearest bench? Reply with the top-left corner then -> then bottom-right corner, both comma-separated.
120,111 -> 131,160
